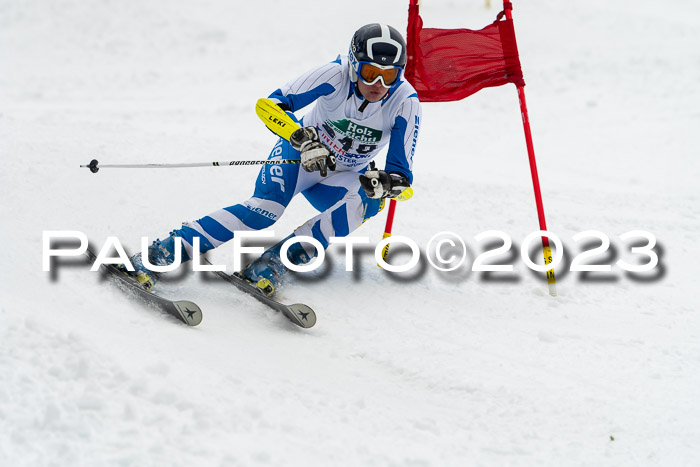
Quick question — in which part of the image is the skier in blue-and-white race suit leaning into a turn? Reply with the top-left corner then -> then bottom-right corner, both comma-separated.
122,23 -> 421,296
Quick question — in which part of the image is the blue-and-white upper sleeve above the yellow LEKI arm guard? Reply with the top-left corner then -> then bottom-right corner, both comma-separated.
269,58 -> 343,112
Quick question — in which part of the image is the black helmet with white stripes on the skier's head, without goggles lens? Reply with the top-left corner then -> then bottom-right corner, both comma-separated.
348,23 -> 406,82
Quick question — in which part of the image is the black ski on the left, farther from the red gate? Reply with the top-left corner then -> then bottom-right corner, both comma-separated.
85,249 -> 202,326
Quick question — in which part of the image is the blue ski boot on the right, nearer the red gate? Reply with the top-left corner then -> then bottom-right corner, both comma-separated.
241,234 -> 315,297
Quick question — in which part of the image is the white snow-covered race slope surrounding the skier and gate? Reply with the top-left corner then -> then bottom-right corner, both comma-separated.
0,0 -> 700,466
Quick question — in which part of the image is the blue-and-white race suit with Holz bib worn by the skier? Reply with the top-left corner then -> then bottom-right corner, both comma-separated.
175,57 -> 421,258
